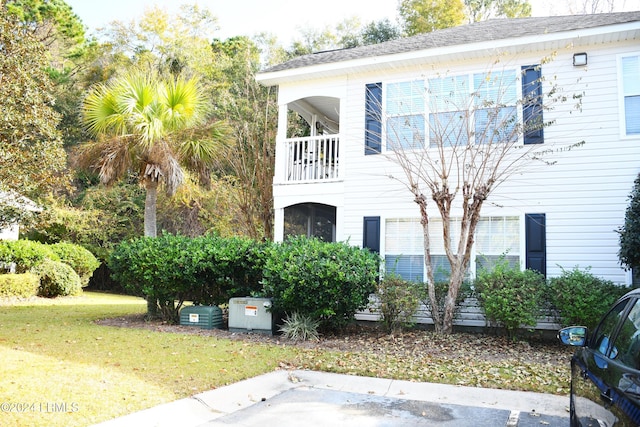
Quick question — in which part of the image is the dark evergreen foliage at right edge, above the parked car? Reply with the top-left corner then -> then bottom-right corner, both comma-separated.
618,175 -> 640,280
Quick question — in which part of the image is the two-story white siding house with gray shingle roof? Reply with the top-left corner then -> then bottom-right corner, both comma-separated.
258,12 -> 640,290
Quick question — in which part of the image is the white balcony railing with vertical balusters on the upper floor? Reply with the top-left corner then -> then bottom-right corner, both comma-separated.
285,134 -> 340,182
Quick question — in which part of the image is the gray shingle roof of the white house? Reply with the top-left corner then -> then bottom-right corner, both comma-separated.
258,11 -> 640,80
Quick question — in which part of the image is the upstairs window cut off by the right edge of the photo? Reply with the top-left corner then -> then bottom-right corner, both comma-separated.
620,55 -> 640,135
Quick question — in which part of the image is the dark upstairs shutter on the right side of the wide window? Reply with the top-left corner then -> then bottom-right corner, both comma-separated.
522,65 -> 544,144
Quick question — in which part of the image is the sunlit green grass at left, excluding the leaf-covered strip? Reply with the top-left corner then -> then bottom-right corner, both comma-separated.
0,292 -> 295,427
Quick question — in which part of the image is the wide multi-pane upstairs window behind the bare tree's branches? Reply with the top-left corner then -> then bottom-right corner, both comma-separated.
366,65 -> 532,151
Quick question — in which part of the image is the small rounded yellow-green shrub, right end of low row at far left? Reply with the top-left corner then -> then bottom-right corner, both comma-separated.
31,259 -> 82,298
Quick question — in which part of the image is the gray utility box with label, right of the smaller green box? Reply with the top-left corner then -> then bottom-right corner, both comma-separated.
229,297 -> 275,335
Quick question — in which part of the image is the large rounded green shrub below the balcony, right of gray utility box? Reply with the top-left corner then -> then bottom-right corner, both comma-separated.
263,237 -> 379,329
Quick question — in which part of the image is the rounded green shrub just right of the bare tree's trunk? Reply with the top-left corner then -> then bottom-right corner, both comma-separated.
475,263 -> 545,337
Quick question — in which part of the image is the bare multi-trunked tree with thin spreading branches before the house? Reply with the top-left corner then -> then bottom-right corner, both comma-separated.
368,54 -> 582,333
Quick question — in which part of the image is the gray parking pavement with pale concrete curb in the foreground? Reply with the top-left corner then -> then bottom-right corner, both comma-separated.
91,370 -> 569,427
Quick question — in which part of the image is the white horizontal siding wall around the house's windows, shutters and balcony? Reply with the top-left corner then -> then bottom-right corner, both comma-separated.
274,38 -> 640,284
